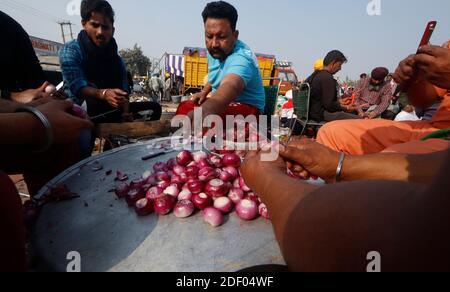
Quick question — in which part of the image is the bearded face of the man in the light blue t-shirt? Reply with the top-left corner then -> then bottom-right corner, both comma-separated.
205,18 -> 239,61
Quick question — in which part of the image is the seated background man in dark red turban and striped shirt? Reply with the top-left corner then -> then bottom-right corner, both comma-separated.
355,67 -> 392,119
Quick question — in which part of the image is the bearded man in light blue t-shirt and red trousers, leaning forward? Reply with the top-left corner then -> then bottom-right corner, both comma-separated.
177,1 -> 265,119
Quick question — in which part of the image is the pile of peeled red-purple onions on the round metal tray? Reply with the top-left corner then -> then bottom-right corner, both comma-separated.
115,149 -> 269,227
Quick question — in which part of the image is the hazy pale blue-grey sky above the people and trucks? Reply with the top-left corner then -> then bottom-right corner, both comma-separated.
0,0 -> 450,80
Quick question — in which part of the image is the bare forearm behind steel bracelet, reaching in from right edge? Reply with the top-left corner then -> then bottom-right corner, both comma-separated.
342,151 -> 448,184
